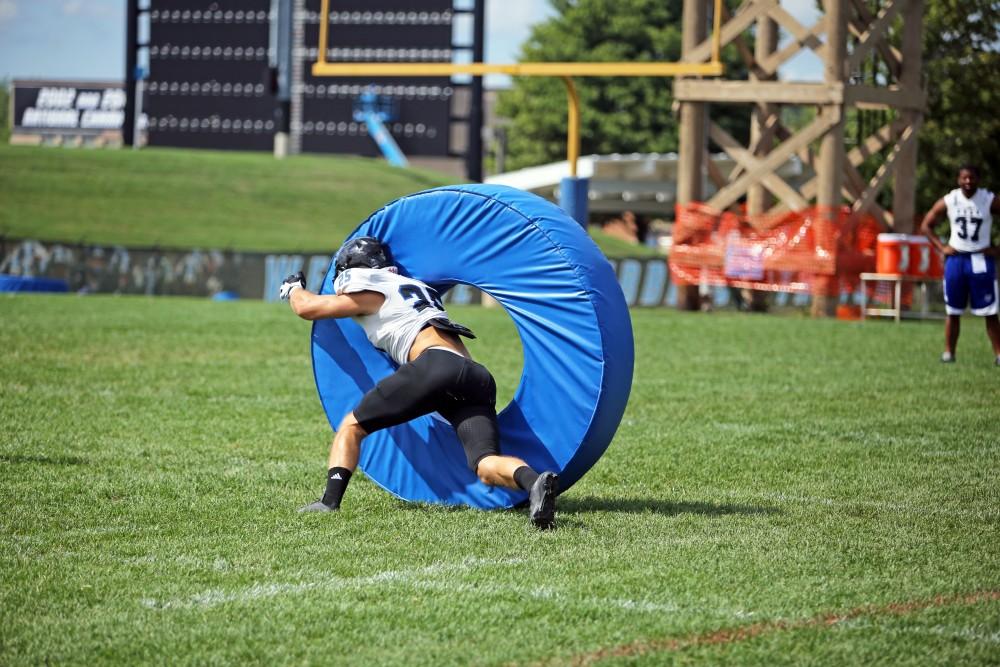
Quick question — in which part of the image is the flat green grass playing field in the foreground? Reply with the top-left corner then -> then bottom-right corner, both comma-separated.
0,296 -> 1000,666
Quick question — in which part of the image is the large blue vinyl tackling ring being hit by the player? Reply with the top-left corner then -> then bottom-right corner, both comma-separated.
312,185 -> 634,509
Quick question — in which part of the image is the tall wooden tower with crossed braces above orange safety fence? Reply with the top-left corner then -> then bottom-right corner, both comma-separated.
674,0 -> 925,314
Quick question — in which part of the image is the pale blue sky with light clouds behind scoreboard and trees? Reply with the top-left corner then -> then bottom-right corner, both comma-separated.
0,0 -> 822,87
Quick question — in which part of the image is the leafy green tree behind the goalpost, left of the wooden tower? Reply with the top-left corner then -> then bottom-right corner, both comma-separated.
497,0 -> 749,169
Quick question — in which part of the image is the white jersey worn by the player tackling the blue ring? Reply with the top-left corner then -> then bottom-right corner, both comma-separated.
333,268 -> 471,366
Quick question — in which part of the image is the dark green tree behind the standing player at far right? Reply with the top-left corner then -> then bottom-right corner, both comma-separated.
917,0 -> 1000,214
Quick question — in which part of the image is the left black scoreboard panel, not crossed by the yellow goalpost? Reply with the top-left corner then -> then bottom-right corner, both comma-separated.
143,0 -> 275,150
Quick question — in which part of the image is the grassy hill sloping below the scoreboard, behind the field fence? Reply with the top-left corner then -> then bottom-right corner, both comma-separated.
0,146 -> 664,256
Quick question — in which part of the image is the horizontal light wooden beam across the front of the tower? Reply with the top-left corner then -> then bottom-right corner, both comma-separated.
674,79 -> 844,105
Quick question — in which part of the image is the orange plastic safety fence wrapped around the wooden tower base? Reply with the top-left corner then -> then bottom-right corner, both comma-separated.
670,203 -> 884,296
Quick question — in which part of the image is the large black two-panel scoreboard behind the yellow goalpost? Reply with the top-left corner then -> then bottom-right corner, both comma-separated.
144,0 -> 458,156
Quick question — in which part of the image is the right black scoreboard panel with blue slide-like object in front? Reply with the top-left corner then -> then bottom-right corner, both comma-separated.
300,0 -> 455,156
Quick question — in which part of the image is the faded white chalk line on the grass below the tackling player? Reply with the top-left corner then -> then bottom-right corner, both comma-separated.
140,558 -> 524,609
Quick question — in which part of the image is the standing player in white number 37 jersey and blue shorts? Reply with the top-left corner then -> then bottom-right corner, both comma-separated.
920,165 -> 1000,366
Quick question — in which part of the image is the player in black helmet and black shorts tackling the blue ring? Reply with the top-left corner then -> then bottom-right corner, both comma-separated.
279,236 -> 559,530
